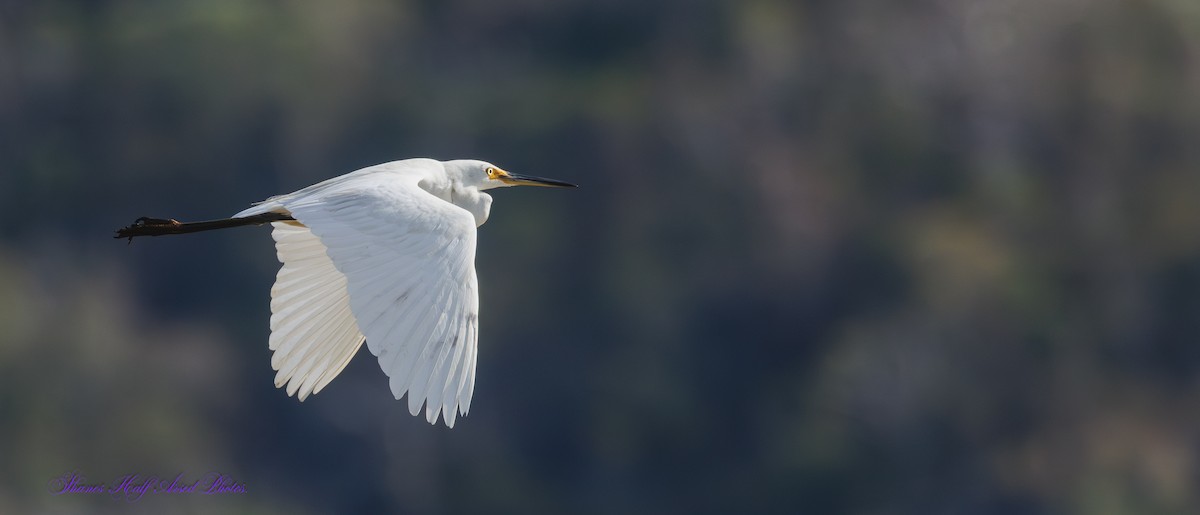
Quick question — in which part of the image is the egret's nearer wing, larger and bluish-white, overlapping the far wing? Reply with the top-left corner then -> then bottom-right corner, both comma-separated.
261,172 -> 479,427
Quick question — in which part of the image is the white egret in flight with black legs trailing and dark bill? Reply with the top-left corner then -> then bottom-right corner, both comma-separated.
116,158 -> 575,427
